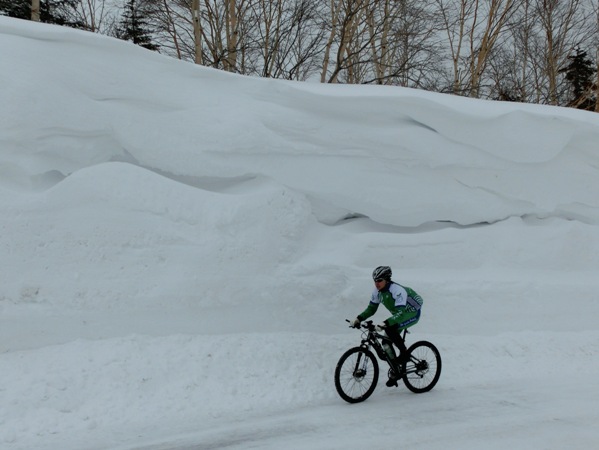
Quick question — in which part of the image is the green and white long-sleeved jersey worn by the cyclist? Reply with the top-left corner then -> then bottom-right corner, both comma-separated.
358,281 -> 423,327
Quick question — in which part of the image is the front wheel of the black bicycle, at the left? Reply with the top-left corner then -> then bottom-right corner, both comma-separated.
335,347 -> 379,403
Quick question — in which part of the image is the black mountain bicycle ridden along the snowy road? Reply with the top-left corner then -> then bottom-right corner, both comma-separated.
335,319 -> 441,403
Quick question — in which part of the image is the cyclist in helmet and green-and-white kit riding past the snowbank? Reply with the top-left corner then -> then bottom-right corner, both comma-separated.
352,266 -> 423,387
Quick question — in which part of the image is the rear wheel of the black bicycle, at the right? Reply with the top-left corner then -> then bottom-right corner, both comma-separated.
403,341 -> 441,394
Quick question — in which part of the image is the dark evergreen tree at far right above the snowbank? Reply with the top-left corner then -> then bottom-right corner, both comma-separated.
561,48 -> 595,111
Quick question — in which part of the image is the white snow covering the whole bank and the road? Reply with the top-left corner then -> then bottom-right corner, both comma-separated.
0,17 -> 599,450
